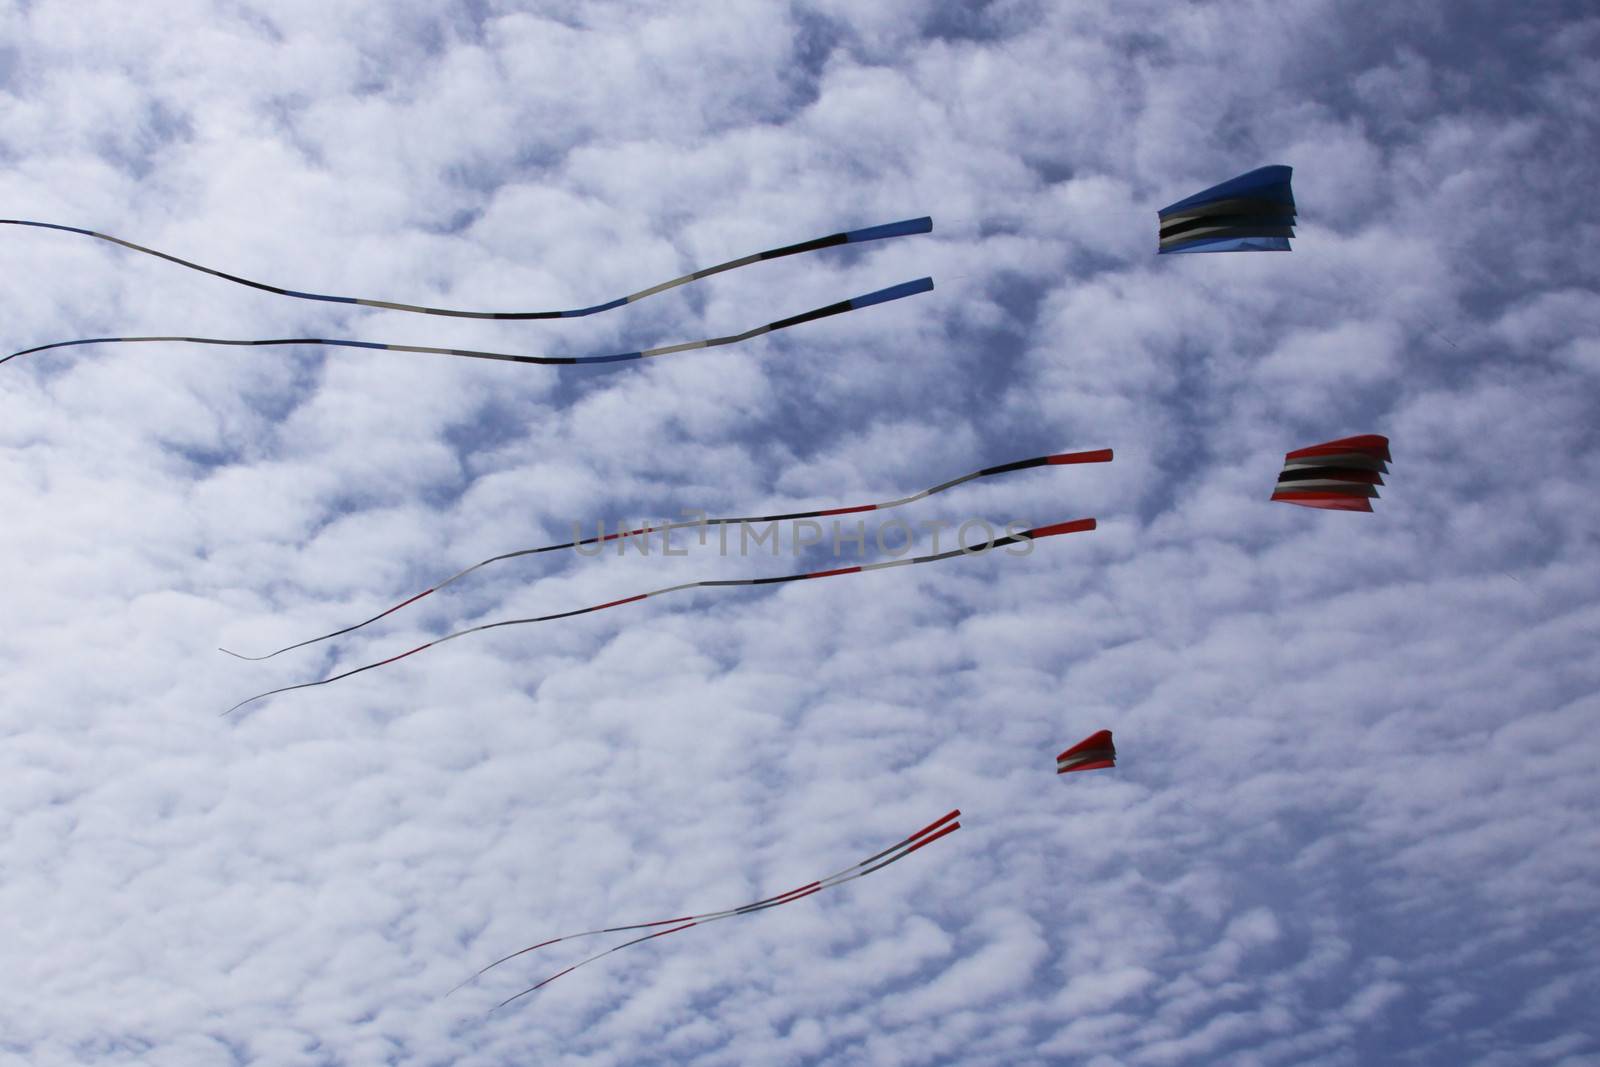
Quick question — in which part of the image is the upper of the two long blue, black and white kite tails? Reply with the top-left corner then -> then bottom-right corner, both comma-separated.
0,216 -> 933,316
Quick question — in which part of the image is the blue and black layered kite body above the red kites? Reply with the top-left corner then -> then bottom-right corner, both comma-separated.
1157,165 -> 1294,256
